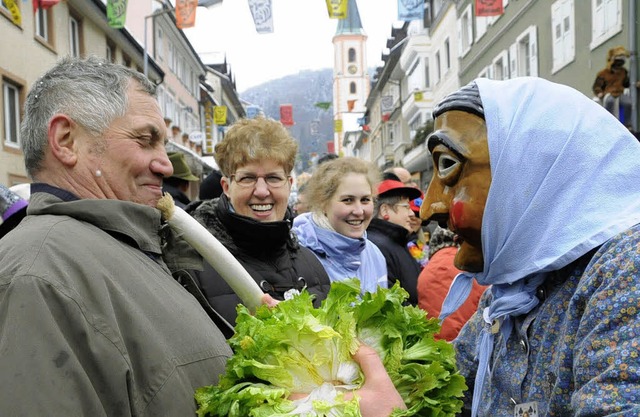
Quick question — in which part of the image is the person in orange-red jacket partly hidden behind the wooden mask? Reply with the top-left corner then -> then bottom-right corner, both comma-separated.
418,227 -> 487,341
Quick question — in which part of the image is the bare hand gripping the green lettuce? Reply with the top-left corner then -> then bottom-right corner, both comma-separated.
353,345 -> 407,417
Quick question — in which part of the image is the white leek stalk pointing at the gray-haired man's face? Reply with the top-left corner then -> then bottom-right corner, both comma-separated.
156,193 -> 265,312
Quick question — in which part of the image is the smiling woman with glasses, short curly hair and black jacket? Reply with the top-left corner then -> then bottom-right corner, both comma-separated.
187,118 -> 330,326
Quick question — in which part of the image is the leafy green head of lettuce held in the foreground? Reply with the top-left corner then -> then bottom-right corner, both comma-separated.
195,279 -> 467,417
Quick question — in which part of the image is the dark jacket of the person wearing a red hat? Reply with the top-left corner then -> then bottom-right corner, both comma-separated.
367,218 -> 420,305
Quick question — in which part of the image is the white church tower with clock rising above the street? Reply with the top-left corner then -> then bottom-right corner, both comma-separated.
333,0 -> 371,156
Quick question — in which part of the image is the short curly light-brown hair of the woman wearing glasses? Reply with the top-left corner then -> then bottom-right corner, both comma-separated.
214,117 -> 298,177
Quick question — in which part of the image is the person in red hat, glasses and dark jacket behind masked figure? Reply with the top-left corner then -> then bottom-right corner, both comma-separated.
367,180 -> 422,305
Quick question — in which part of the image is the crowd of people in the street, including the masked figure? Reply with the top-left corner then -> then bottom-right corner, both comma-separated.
0,58 -> 640,417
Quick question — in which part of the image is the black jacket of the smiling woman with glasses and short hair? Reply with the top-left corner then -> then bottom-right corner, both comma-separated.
186,194 -> 331,325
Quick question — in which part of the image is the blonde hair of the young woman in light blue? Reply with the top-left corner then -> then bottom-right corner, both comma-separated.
305,157 -> 381,212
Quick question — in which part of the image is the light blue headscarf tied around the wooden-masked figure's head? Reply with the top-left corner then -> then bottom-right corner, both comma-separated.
441,77 -> 640,417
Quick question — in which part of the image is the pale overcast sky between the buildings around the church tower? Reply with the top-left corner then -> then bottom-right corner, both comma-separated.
184,0 -> 402,93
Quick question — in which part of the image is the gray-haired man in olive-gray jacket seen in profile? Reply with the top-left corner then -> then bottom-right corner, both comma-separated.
0,58 -> 231,416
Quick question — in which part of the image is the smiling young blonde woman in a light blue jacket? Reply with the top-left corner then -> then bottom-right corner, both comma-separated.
293,157 -> 387,292
